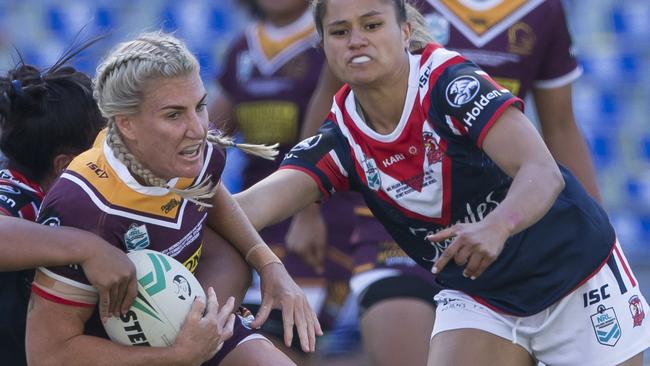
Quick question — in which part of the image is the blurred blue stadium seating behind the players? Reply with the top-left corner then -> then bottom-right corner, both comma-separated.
0,0 -> 650,295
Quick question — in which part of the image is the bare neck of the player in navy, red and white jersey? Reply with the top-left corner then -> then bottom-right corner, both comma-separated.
351,56 -> 409,135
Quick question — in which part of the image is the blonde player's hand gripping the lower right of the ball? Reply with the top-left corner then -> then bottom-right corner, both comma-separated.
172,287 -> 235,365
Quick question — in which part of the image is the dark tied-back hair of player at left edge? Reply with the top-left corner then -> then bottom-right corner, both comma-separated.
0,39 -> 106,182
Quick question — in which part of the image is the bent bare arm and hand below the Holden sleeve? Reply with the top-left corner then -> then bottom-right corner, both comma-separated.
428,107 -> 564,279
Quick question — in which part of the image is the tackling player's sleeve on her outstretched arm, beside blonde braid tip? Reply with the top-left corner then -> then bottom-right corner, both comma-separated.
280,120 -> 350,199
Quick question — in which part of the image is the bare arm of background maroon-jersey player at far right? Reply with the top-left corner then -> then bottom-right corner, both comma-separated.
533,84 -> 602,201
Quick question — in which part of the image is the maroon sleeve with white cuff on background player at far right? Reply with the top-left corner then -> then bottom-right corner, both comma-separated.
533,0 -> 582,89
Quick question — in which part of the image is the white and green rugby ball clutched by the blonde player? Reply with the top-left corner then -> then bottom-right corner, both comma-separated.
104,249 -> 205,347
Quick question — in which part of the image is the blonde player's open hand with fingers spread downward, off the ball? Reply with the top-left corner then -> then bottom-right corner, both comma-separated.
251,262 -> 323,352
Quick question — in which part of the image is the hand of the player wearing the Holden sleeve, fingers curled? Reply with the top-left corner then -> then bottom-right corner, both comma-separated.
427,217 -> 510,280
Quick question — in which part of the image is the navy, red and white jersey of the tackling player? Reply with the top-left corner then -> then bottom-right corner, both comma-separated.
282,44 -> 614,315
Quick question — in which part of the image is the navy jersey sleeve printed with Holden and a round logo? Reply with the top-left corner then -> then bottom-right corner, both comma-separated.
429,60 -> 524,148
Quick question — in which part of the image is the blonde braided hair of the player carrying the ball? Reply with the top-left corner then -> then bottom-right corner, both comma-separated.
93,32 -> 278,207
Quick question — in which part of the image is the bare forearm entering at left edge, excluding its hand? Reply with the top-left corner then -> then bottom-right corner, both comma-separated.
0,216 -> 101,271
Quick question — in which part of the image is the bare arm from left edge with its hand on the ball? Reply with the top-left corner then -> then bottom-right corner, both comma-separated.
0,214 -> 138,319
